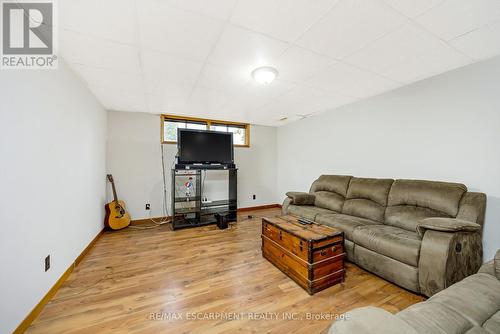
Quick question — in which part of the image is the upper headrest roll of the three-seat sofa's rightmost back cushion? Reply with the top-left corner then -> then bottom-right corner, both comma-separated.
388,180 -> 467,217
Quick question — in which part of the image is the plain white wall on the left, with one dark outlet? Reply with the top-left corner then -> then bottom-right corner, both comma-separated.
0,61 -> 106,333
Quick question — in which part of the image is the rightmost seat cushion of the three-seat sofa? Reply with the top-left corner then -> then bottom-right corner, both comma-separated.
353,225 -> 422,267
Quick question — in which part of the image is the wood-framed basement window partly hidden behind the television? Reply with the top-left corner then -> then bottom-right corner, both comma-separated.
161,115 -> 250,147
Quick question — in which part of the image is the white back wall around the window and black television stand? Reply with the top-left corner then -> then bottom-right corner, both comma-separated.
107,111 -> 277,219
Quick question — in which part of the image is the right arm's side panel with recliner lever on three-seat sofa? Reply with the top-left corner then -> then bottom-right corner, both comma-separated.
418,229 -> 483,297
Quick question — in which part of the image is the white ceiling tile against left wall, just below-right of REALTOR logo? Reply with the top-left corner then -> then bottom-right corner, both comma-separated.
73,65 -> 144,92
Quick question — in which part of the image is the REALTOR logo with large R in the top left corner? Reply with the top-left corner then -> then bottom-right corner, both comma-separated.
0,0 -> 57,69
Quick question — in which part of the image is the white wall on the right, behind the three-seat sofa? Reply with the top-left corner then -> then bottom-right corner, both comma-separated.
278,57 -> 500,259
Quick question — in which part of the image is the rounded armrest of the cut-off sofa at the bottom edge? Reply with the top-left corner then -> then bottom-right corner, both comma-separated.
328,306 -> 417,334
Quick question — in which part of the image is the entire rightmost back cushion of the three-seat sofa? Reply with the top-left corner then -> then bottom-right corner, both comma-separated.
385,180 -> 467,231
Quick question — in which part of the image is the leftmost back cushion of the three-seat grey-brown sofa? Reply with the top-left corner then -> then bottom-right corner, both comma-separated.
309,175 -> 352,212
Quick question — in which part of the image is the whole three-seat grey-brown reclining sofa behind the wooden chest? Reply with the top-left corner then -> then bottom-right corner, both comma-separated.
282,175 -> 486,296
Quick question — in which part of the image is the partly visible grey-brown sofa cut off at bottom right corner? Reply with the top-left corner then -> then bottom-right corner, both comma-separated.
328,250 -> 500,334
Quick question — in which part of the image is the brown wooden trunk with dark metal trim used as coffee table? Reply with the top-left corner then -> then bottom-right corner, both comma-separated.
261,216 -> 345,295
